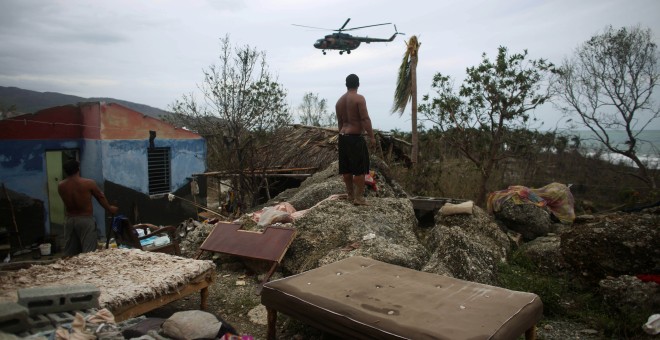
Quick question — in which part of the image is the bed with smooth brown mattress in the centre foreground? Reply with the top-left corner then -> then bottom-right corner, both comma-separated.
261,256 -> 543,339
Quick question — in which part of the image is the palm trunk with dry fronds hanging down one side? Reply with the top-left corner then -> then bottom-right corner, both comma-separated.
392,35 -> 421,166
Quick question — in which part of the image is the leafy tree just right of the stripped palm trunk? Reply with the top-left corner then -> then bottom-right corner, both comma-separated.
419,47 -> 553,206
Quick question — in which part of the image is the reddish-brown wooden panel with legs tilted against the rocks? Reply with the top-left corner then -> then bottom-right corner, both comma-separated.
197,222 -> 296,290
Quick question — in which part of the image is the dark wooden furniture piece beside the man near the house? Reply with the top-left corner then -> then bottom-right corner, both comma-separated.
112,218 -> 181,255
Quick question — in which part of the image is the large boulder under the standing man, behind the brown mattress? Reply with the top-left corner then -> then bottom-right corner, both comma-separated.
282,197 -> 428,273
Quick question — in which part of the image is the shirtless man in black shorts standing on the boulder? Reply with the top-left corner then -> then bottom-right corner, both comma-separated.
335,74 -> 376,205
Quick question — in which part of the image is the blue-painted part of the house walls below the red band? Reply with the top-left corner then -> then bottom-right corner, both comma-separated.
0,139 -> 206,235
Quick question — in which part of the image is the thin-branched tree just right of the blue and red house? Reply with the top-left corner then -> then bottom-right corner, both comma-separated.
167,36 -> 291,210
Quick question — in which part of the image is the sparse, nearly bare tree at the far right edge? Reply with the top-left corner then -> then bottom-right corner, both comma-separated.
555,26 -> 660,189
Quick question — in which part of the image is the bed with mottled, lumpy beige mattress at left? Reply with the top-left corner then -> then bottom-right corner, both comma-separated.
0,248 -> 215,322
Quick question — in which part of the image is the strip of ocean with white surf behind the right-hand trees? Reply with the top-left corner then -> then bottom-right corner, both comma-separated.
562,130 -> 660,169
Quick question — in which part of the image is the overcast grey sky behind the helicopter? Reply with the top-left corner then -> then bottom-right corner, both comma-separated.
0,0 -> 660,131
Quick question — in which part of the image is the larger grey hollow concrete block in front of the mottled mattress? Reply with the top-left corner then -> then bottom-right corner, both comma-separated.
17,284 -> 101,315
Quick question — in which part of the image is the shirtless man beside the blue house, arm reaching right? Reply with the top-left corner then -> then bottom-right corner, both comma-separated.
57,160 -> 118,257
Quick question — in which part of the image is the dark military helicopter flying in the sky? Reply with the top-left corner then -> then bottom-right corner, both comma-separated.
292,18 -> 403,55
